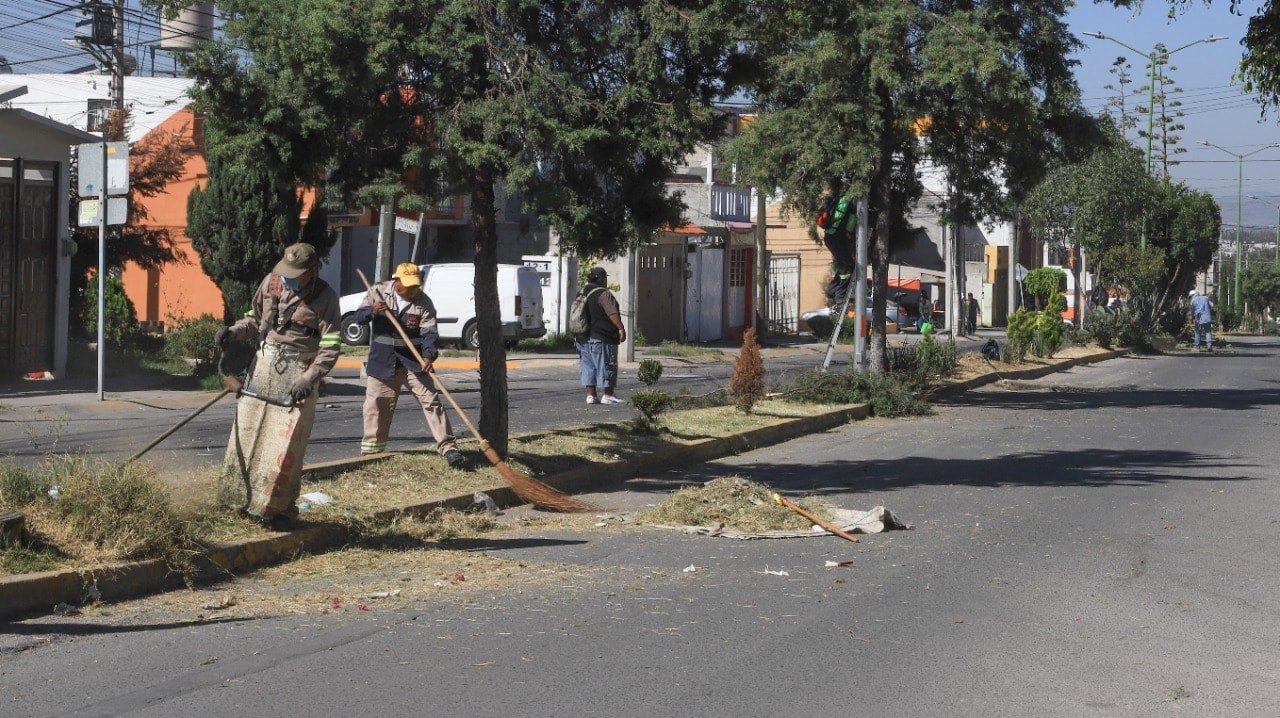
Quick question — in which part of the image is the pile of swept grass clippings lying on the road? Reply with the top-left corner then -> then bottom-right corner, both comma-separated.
636,476 -> 832,531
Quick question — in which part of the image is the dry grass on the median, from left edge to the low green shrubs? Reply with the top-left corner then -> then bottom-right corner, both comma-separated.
0,402 -> 849,576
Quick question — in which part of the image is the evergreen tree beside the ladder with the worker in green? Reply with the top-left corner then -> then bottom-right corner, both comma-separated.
731,0 -> 1092,371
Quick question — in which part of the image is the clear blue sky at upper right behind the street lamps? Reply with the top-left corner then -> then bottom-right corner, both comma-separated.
1068,0 -> 1280,227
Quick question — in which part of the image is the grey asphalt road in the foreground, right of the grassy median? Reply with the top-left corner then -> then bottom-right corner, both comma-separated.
0,339 -> 1280,718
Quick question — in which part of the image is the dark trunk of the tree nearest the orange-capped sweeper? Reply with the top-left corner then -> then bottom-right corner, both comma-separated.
471,168 -> 507,456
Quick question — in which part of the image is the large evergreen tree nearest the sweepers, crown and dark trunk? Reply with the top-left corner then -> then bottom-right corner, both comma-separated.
163,0 -> 737,453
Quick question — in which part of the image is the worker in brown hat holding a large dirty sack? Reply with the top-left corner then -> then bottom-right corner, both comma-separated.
215,242 -> 342,523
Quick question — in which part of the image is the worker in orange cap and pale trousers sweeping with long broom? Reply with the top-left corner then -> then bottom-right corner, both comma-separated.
356,262 -> 466,468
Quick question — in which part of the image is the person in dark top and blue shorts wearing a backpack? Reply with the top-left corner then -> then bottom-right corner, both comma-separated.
573,266 -> 627,404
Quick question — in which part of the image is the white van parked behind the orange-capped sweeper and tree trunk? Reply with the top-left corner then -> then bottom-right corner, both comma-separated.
339,262 -> 547,349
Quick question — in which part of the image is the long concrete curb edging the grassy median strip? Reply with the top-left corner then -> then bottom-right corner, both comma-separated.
0,349 -> 1128,618
